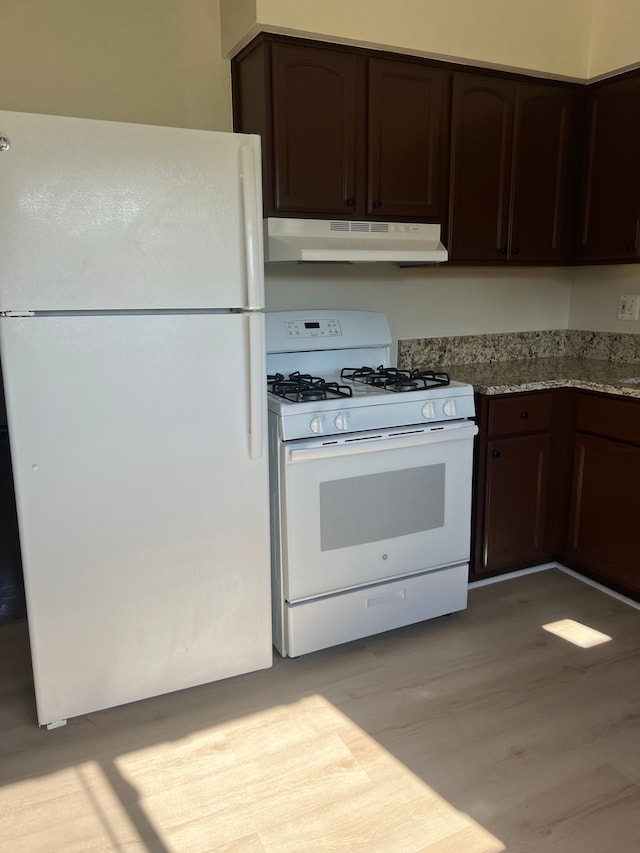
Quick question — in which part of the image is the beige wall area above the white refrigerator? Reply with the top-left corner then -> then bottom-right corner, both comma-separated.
0,0 -> 231,130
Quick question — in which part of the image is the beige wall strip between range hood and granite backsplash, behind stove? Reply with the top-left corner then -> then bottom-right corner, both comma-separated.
266,264 -> 571,346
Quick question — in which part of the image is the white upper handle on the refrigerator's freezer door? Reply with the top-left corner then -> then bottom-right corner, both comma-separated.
240,145 -> 264,309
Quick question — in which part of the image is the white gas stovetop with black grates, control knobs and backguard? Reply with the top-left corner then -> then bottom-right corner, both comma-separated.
267,311 -> 475,440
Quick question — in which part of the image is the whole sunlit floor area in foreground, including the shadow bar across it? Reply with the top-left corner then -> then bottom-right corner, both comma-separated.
0,695 -> 505,853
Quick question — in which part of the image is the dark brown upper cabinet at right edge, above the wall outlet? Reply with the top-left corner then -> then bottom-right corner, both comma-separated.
576,74 -> 640,263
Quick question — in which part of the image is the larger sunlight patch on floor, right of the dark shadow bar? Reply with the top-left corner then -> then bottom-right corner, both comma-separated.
111,695 -> 505,853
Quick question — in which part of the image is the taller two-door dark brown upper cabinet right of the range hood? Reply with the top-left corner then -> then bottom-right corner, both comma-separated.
449,73 -> 577,264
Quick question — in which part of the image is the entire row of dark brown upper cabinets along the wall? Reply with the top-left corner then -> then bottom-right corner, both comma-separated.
231,33 -> 640,266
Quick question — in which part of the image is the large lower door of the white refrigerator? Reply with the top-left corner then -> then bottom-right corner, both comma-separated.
0,314 -> 272,724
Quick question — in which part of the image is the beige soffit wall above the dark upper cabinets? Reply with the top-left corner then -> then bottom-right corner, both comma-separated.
222,0 -> 600,79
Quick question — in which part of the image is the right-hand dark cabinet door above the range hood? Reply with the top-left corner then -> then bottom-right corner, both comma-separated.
366,59 -> 450,221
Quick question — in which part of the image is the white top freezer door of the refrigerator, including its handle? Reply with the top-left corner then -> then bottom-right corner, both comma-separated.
0,111 -> 264,311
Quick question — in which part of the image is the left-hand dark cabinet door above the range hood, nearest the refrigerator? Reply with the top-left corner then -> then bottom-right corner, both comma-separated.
272,43 -> 364,215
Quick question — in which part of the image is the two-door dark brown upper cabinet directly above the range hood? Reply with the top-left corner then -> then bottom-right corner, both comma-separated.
232,36 -> 450,221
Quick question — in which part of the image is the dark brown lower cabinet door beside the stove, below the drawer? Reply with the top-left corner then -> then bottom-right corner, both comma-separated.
480,432 -> 551,572
